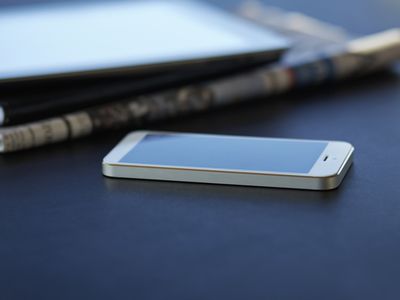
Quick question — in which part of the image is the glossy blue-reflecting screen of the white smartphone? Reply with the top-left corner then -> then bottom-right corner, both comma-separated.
120,134 -> 328,173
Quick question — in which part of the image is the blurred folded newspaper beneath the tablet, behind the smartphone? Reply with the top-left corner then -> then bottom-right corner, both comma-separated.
0,29 -> 400,153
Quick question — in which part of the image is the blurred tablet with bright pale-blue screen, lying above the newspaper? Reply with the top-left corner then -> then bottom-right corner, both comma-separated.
0,1 -> 288,82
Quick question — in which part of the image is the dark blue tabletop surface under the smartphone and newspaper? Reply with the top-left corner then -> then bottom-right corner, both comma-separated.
0,0 -> 400,299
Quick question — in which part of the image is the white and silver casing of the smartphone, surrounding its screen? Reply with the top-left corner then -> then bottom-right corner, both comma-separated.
102,130 -> 354,190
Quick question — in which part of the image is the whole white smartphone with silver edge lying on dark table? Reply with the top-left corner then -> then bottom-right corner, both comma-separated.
103,131 -> 354,190
